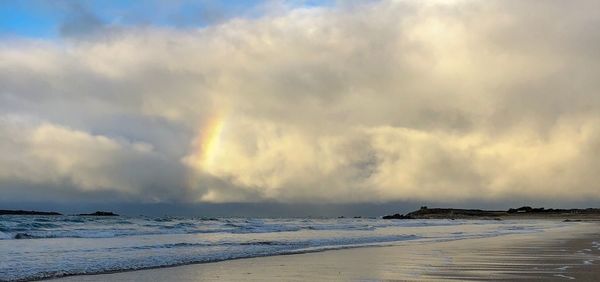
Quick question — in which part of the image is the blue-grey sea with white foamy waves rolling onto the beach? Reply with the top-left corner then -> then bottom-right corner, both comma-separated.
0,216 -> 573,281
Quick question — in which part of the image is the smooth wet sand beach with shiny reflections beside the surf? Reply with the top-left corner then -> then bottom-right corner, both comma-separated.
57,223 -> 600,281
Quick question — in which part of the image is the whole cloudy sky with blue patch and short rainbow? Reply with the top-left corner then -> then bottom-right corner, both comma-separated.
0,0 -> 600,214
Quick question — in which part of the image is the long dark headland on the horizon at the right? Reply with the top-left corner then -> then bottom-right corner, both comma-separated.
383,206 -> 600,219
